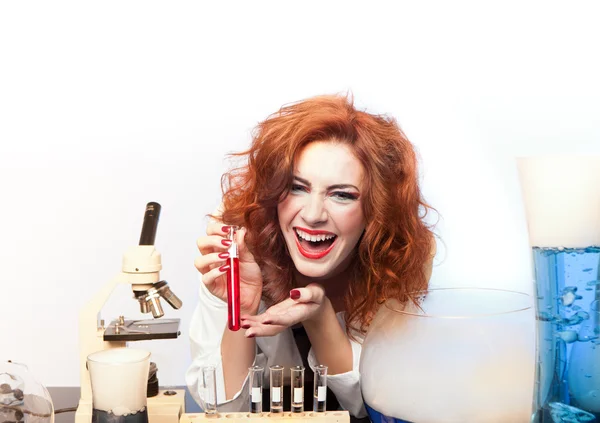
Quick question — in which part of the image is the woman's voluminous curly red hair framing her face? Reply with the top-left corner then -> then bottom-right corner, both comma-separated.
221,95 -> 435,333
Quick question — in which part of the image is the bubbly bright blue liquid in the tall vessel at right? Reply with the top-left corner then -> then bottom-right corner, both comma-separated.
533,246 -> 600,423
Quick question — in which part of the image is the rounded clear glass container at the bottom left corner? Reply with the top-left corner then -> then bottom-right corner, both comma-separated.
0,361 -> 54,423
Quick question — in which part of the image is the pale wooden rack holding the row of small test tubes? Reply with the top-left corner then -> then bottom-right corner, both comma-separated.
179,411 -> 350,423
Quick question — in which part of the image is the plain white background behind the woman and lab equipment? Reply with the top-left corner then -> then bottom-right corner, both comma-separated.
0,1 -> 600,386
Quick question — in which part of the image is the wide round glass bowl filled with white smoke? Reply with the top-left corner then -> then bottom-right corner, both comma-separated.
360,288 -> 535,423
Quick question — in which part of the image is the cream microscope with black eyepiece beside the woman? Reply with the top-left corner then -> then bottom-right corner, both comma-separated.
75,202 -> 185,423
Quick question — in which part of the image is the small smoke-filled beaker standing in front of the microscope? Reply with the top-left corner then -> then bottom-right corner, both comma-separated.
87,348 -> 150,423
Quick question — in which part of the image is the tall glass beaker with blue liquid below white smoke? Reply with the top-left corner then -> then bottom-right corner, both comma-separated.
518,156 -> 600,423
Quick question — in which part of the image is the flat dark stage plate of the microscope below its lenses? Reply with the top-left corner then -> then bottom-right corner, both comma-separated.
104,319 -> 181,341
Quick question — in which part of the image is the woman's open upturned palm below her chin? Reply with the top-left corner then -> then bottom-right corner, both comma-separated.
241,283 -> 330,338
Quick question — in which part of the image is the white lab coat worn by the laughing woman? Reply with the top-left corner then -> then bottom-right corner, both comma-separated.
186,281 -> 367,417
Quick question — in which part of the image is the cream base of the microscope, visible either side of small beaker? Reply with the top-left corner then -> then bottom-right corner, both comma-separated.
75,389 -> 185,423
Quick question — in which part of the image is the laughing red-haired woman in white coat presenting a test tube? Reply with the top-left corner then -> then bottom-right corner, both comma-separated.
187,96 -> 435,417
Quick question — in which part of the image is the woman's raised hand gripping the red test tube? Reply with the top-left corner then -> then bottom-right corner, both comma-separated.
194,221 -> 262,313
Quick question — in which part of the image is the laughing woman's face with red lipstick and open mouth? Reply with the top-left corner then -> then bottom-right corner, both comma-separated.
277,141 -> 365,279
